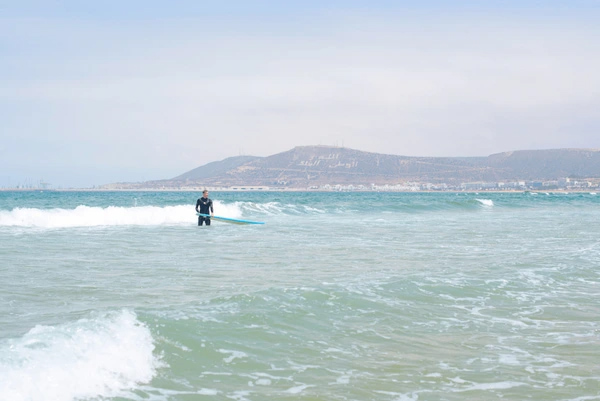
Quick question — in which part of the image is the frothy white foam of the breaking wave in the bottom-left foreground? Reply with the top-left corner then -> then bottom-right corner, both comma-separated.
0,310 -> 160,401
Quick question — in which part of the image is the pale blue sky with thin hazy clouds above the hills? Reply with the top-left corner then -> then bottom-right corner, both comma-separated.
0,0 -> 600,188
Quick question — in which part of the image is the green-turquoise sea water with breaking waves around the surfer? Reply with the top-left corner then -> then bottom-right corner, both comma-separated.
0,191 -> 600,401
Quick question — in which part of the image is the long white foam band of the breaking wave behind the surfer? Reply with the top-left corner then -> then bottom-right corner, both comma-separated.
0,202 -> 241,228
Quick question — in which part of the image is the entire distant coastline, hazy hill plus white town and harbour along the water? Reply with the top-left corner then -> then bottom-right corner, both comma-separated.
8,146 -> 600,192
